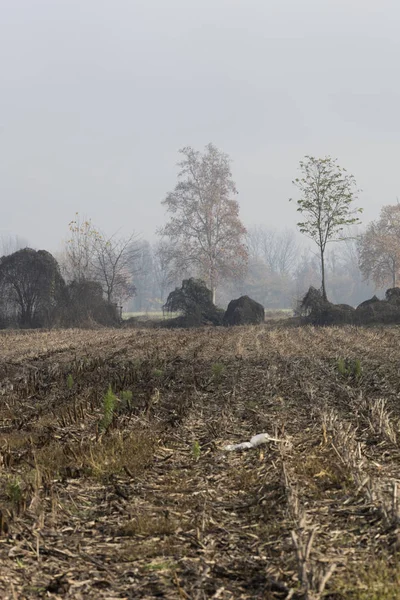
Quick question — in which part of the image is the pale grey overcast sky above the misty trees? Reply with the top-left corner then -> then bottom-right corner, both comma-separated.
0,0 -> 400,251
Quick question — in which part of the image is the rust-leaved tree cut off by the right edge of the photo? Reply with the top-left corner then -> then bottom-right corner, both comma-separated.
359,204 -> 400,287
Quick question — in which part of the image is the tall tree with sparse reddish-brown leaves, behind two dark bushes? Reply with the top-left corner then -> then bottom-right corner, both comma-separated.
159,144 -> 247,301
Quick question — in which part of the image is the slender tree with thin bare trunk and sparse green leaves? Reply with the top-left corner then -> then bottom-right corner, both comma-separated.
293,156 -> 362,300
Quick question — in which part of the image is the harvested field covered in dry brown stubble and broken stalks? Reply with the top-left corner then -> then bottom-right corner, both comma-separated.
0,324 -> 400,600
